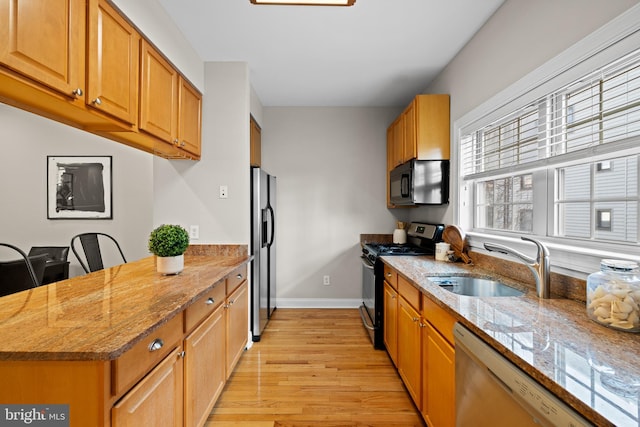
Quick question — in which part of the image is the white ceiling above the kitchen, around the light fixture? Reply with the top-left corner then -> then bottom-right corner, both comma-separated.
158,0 -> 504,107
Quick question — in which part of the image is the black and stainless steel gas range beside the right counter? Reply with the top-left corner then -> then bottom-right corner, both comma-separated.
360,222 -> 444,350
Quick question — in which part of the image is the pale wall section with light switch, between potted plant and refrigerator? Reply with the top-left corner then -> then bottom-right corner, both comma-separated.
153,62 -> 251,244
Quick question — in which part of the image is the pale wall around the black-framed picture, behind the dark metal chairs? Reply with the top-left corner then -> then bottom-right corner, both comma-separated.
0,104 -> 153,276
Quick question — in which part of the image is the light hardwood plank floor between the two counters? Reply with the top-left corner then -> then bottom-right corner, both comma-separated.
205,308 -> 425,427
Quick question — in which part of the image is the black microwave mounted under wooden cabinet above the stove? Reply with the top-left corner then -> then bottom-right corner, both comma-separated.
389,160 -> 449,206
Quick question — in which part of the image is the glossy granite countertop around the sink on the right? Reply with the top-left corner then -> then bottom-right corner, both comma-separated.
382,256 -> 640,426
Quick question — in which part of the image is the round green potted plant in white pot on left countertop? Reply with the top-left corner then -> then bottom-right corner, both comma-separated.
149,224 -> 189,274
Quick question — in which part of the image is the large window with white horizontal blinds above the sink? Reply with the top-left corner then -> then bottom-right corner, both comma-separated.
460,51 -> 640,266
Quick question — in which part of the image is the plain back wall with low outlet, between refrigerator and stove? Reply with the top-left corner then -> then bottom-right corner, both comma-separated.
262,107 -> 398,307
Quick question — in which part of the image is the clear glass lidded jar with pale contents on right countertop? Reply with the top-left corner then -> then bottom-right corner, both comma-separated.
587,259 -> 640,332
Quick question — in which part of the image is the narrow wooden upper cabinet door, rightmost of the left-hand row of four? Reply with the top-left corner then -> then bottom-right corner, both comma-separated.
178,77 -> 202,156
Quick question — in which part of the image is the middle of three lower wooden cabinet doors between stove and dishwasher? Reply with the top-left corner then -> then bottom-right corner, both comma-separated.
398,295 -> 422,409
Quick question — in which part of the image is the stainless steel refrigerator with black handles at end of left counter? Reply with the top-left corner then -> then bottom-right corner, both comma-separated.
251,168 -> 276,341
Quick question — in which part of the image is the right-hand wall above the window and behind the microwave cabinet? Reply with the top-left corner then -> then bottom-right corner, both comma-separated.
411,0 -> 638,227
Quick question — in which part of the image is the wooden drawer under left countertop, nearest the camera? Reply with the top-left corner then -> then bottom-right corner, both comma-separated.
111,315 -> 184,396
